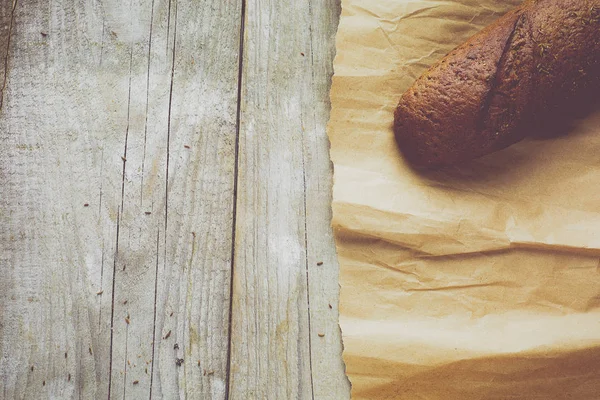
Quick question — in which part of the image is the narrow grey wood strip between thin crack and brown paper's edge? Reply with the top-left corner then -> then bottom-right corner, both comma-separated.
300,0 -> 350,400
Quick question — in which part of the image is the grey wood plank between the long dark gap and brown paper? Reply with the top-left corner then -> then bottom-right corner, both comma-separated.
230,0 -> 349,399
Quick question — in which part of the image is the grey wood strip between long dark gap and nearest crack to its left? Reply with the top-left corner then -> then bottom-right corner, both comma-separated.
159,0 -> 242,399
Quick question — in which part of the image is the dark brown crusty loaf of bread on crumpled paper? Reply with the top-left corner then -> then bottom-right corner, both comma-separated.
394,0 -> 600,167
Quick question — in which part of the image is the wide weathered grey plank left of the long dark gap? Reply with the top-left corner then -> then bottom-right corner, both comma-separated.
0,0 -> 241,399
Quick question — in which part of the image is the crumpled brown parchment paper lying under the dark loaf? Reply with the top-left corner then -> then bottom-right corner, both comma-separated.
328,0 -> 600,400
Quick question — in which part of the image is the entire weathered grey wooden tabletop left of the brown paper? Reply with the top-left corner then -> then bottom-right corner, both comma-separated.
0,0 -> 349,400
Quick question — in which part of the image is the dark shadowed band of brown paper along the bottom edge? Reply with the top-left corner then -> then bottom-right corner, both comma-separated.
347,347 -> 600,400
